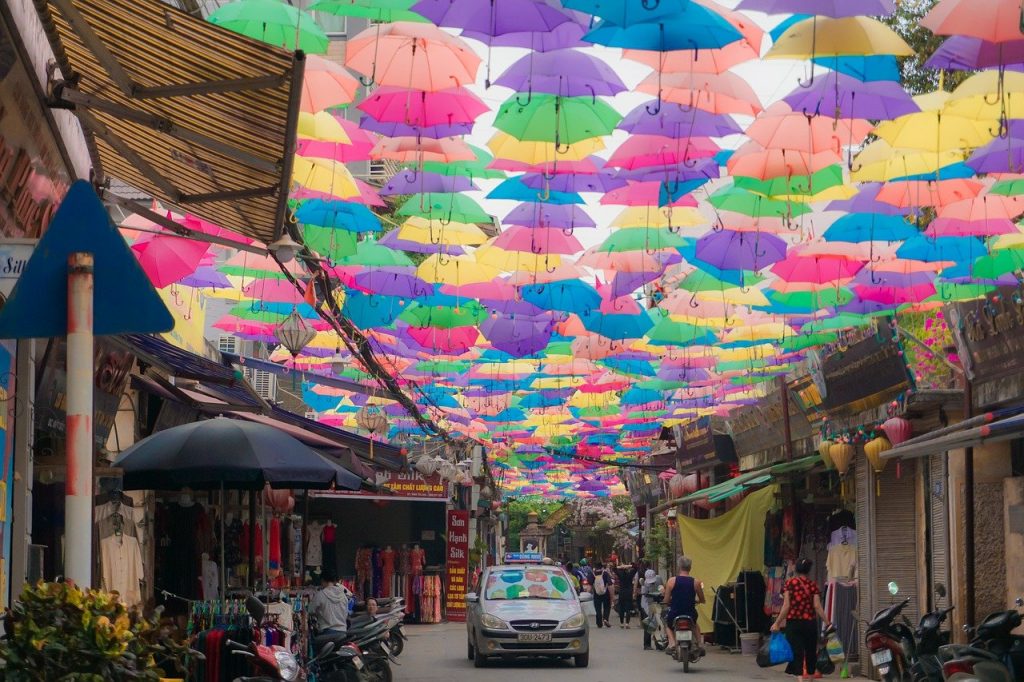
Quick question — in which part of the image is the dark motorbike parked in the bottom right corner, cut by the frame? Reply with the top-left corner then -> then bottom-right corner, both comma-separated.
939,598 -> 1024,682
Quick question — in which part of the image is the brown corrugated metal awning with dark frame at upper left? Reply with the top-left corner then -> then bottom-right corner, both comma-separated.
35,0 -> 304,243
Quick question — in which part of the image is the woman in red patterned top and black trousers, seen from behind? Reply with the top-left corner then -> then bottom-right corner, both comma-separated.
771,559 -> 828,680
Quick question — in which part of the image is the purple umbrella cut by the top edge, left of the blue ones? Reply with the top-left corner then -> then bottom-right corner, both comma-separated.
410,0 -> 572,36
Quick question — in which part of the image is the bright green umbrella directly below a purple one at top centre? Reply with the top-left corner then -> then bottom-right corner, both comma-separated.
495,93 -> 623,144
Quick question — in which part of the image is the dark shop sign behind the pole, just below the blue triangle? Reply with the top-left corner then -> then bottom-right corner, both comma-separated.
36,339 -> 135,447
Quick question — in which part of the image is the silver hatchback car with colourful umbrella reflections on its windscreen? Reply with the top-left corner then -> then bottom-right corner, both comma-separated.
466,564 -> 594,668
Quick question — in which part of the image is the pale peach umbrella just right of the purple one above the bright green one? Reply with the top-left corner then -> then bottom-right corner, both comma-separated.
636,72 -> 763,116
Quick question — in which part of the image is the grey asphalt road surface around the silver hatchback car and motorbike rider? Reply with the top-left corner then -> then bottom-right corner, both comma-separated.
394,623 -> 802,682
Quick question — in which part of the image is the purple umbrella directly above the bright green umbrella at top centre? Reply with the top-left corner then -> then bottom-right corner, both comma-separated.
495,49 -> 626,95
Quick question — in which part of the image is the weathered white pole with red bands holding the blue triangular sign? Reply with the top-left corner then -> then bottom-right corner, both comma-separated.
65,253 -> 95,588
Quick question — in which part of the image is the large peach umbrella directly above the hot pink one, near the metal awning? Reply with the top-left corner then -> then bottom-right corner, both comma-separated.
345,22 -> 480,92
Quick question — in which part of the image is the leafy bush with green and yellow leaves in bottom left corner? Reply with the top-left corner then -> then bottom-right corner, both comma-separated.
0,583 -> 188,682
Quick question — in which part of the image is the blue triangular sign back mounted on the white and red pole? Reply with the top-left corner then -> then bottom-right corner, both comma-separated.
0,180 -> 174,339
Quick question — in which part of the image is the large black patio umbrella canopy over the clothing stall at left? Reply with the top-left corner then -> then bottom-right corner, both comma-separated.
114,417 -> 362,491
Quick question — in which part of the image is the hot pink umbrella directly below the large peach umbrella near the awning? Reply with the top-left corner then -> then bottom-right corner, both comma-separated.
356,83 -> 487,127
